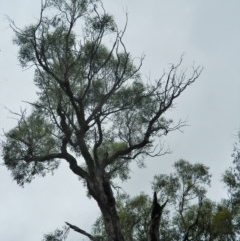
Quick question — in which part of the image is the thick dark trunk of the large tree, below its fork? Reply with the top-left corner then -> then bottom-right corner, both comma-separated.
88,170 -> 124,241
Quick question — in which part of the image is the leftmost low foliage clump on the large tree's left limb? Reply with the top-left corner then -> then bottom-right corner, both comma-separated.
2,113 -> 58,186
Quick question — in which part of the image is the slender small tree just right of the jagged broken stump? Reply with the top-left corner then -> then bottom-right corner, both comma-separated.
153,160 -> 211,241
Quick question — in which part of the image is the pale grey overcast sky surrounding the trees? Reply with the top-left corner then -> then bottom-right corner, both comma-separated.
0,0 -> 240,241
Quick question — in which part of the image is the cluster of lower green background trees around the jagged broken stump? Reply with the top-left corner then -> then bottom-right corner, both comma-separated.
93,154 -> 240,241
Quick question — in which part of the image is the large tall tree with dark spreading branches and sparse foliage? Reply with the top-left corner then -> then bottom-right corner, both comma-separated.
3,0 -> 201,241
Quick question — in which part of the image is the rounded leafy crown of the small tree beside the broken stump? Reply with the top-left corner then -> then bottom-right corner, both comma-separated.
152,160 -> 211,205
